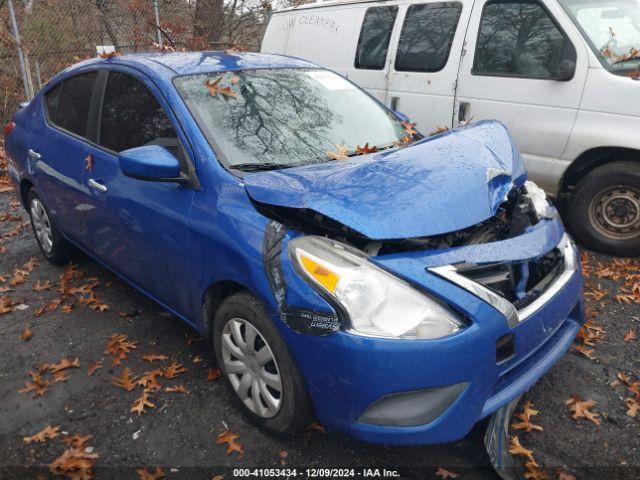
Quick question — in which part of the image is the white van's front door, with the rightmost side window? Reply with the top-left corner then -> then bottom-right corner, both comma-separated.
456,0 -> 588,188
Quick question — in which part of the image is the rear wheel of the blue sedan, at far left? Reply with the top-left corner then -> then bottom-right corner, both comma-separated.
27,188 -> 74,265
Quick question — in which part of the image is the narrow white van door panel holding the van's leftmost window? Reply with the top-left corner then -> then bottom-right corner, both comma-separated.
348,5 -> 398,105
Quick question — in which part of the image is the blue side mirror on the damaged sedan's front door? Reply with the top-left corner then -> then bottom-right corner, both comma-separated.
118,145 -> 183,182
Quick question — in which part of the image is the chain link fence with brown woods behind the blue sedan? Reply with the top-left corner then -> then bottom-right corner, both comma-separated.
0,0 -> 274,125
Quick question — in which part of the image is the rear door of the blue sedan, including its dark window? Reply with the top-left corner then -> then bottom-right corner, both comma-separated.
28,71 -> 97,247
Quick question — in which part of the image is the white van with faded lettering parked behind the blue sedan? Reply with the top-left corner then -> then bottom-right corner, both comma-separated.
262,0 -> 640,256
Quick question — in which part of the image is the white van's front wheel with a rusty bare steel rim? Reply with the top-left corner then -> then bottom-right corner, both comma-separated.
568,162 -> 640,257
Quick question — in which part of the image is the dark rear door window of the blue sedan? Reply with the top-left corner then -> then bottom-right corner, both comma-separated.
46,72 -> 98,137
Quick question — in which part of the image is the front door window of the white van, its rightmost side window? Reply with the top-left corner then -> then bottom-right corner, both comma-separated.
473,0 -> 569,78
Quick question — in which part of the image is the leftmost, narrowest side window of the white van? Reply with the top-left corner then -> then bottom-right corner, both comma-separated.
355,7 -> 398,70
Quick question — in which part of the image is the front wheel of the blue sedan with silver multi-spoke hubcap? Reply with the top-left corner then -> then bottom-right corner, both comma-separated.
213,292 -> 313,434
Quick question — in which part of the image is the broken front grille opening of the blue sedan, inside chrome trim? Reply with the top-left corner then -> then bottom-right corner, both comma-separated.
457,248 -> 564,310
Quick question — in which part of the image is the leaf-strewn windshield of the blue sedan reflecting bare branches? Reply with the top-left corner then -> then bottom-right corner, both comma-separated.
174,69 -> 415,169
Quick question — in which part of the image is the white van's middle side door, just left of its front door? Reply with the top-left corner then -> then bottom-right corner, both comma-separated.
388,1 -> 472,134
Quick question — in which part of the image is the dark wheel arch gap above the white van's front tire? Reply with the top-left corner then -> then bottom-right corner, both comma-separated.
559,147 -> 640,194
